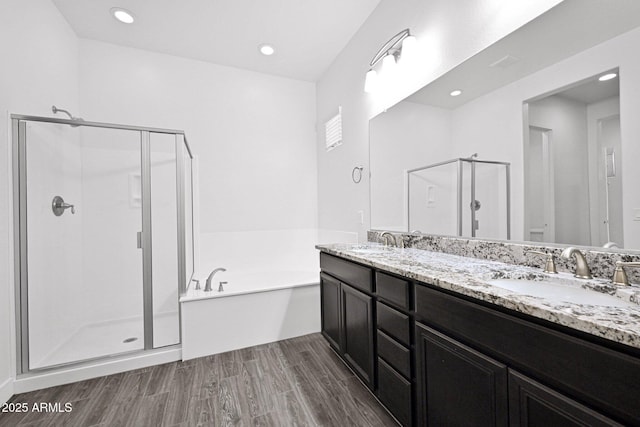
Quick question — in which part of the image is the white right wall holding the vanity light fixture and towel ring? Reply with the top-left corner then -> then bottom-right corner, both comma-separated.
317,0 -> 560,240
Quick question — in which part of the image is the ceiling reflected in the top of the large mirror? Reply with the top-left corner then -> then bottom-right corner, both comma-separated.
407,0 -> 640,109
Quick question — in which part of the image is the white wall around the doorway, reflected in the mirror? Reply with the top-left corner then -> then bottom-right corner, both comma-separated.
452,24 -> 640,248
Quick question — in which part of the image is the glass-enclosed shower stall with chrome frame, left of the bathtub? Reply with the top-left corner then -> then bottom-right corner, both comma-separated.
11,115 -> 194,374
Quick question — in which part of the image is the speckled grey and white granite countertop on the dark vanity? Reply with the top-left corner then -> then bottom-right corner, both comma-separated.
316,244 -> 640,348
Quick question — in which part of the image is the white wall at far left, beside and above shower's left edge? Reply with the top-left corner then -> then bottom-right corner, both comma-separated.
0,0 -> 78,401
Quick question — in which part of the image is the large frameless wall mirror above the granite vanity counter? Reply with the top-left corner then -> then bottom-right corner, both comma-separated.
369,0 -> 640,249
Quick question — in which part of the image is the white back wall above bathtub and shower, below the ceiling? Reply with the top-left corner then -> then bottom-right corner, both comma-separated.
80,40 -> 317,233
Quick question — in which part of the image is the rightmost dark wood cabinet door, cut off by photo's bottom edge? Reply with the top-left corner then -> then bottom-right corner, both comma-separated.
509,370 -> 620,427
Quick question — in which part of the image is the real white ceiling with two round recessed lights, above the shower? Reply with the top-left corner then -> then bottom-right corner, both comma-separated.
52,0 -> 380,82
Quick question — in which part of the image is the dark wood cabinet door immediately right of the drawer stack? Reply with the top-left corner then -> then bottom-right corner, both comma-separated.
415,322 -> 510,427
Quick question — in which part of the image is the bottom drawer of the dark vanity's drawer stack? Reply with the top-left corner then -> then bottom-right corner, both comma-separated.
378,358 -> 413,426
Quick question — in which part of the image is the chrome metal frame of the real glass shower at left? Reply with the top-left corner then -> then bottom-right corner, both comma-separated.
11,114 -> 193,375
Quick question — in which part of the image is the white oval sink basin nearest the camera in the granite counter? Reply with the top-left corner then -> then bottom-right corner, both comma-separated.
487,279 -> 637,307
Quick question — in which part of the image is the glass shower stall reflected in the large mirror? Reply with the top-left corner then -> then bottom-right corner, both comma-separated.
406,154 -> 511,239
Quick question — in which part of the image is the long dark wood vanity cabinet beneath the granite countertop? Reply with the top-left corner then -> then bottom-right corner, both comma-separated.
320,253 -> 640,427
